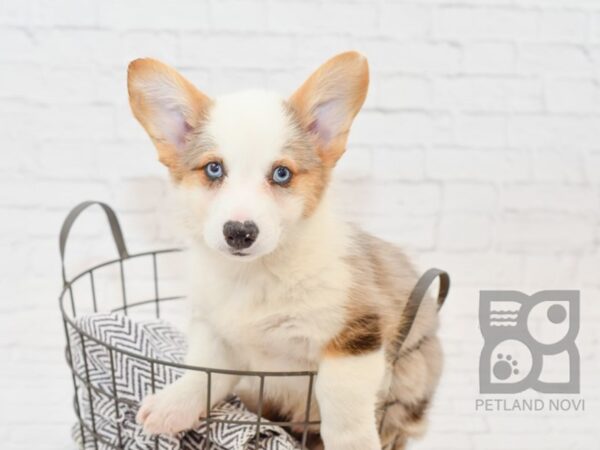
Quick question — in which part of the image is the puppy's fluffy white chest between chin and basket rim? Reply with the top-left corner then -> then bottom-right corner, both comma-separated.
192,243 -> 349,370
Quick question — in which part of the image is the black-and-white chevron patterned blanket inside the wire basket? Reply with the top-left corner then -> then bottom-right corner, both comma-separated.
69,314 -> 300,450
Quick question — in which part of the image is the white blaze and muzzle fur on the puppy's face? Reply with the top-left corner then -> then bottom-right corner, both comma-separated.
192,91 -> 302,260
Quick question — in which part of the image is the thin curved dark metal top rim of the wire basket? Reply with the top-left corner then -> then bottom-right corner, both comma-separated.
58,248 -> 317,378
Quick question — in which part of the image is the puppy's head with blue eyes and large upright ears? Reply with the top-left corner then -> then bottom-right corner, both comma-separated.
128,52 -> 369,260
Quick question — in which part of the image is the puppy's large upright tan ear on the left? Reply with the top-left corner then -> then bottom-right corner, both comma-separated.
127,59 -> 211,169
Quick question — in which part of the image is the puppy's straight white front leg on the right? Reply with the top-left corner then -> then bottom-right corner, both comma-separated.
315,350 -> 385,450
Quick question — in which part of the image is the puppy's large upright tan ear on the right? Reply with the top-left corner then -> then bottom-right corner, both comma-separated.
290,52 -> 369,166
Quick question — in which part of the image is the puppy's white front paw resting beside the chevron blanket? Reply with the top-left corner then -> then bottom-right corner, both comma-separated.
136,382 -> 206,434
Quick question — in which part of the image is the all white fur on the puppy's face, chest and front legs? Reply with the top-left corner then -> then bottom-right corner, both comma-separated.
138,92 -> 383,450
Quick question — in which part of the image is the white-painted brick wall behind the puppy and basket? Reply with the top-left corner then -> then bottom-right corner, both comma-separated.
0,0 -> 600,450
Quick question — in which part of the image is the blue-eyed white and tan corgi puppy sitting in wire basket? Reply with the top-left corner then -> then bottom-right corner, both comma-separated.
128,52 -> 441,450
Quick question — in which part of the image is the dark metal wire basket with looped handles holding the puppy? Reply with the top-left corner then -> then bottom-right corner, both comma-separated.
59,201 -> 450,450
